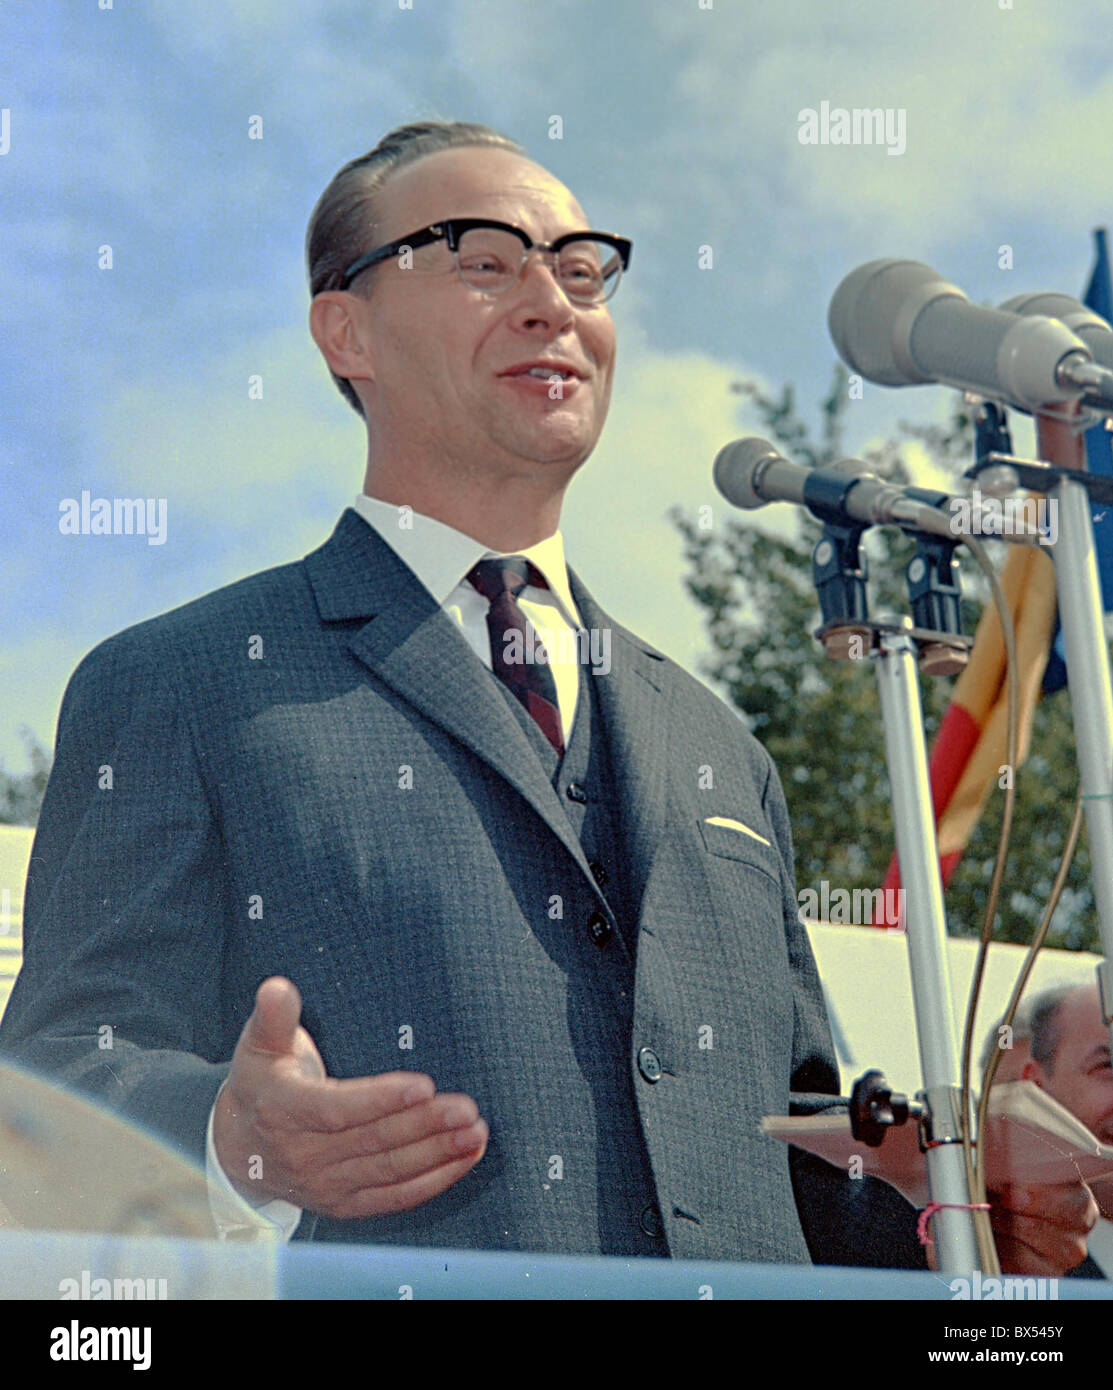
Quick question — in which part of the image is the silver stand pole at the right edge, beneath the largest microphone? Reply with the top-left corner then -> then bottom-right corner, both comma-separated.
1050,478 -> 1113,1038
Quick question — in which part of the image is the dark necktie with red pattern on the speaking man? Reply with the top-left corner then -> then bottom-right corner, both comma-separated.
467,555 -> 564,753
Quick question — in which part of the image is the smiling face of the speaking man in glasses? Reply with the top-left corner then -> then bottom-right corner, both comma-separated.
347,147 -> 614,477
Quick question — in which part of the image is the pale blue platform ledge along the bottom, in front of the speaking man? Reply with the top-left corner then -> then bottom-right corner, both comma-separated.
0,1230 -> 1113,1302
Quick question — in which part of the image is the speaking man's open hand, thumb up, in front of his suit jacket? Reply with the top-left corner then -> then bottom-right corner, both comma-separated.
213,976 -> 488,1218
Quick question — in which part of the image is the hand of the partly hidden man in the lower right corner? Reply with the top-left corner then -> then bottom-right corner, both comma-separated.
989,1183 -> 1098,1277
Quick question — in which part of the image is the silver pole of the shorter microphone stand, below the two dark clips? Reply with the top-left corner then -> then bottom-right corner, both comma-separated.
875,619 -> 978,1275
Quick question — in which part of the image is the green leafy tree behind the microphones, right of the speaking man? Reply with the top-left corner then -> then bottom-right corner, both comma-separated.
671,366 -> 1098,949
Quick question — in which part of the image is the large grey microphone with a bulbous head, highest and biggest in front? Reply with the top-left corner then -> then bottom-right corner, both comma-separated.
827,260 -> 1113,410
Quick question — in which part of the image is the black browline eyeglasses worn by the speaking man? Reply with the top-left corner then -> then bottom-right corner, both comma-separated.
335,217 -> 632,304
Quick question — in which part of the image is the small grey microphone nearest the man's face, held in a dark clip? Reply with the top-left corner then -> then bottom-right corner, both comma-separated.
714,436 -> 957,541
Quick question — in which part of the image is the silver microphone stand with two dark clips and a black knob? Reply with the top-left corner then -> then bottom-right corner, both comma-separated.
809,475 -> 982,1276
